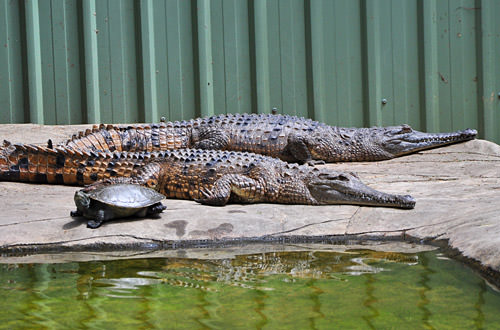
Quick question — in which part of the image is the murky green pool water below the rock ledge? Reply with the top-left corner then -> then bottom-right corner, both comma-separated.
0,250 -> 500,329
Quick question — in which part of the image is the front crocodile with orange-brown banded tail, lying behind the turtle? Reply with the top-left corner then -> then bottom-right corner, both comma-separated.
0,142 -> 415,209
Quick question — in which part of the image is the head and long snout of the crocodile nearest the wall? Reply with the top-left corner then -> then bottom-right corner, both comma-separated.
375,125 -> 477,157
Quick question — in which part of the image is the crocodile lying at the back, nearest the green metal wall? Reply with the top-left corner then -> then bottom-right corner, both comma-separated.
63,114 -> 477,164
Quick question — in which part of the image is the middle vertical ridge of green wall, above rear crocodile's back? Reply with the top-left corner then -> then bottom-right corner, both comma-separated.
254,0 -> 271,113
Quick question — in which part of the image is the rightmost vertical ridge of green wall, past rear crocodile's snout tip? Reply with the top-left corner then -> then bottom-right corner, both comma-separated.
475,0 -> 500,141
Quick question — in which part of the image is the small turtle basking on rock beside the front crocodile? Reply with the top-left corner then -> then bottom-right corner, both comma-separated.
70,183 -> 167,229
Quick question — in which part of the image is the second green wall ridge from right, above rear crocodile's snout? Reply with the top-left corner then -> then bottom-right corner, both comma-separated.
419,0 -> 440,132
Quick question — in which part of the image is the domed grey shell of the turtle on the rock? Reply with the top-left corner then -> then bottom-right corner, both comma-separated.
89,184 -> 165,208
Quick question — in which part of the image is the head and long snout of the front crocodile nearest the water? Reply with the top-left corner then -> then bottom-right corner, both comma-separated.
308,172 -> 415,209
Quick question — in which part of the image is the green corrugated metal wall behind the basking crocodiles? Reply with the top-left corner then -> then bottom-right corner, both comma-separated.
0,0 -> 500,142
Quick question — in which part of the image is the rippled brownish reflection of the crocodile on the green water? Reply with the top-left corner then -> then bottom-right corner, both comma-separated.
79,250 -> 418,297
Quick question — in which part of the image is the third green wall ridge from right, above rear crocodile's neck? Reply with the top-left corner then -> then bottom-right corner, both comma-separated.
361,0 -> 382,126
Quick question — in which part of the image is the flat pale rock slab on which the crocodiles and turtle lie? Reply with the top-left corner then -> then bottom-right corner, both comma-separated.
0,124 -> 500,271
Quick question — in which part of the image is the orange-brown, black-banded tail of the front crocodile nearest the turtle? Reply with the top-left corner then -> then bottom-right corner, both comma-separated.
0,141 -> 152,186
